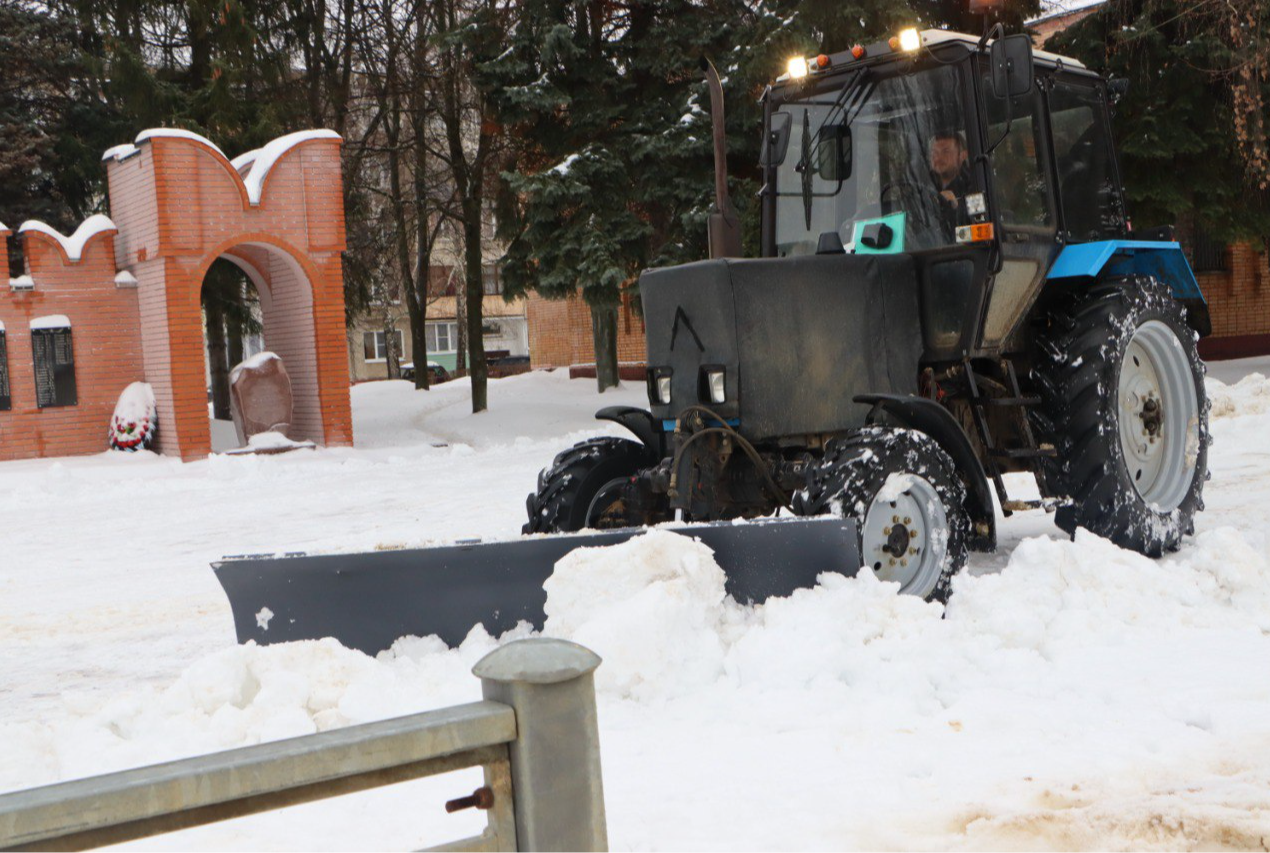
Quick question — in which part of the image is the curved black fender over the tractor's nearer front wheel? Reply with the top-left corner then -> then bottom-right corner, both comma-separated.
855,393 -> 997,551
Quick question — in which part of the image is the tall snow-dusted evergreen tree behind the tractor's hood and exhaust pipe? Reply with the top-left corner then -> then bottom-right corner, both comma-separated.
478,0 -> 1039,390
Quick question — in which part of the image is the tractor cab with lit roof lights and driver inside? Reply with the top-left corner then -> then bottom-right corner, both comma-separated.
762,30 -> 1128,360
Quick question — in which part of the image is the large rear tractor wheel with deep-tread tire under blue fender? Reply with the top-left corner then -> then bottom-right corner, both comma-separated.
1033,277 -> 1209,557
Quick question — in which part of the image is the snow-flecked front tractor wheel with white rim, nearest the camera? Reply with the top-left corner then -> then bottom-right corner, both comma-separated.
794,427 -> 970,602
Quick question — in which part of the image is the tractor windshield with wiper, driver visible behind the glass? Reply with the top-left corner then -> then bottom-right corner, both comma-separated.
772,65 -> 982,255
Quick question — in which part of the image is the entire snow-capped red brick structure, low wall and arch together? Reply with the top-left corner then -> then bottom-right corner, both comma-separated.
0,129 -> 353,460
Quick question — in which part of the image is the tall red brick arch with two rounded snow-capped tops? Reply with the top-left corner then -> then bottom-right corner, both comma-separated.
105,132 -> 353,460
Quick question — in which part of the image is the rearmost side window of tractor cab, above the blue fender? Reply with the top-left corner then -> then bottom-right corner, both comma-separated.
1049,83 -> 1120,241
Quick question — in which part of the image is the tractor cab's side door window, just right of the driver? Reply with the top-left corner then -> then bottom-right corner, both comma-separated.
984,77 -> 1054,231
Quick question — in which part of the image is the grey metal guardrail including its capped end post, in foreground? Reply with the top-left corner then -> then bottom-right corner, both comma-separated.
0,638 -> 607,853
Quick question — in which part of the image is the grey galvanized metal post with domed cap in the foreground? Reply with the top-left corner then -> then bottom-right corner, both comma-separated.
472,637 -> 608,853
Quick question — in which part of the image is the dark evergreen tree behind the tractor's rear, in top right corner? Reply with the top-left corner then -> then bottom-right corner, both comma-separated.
1046,0 -> 1270,237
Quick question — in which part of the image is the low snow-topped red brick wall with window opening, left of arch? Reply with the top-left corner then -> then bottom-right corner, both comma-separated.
0,219 -> 144,460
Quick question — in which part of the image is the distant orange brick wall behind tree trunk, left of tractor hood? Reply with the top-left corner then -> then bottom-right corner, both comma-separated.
526,293 -> 646,368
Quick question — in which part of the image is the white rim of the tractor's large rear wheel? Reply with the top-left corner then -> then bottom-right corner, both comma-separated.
1116,320 -> 1199,513
